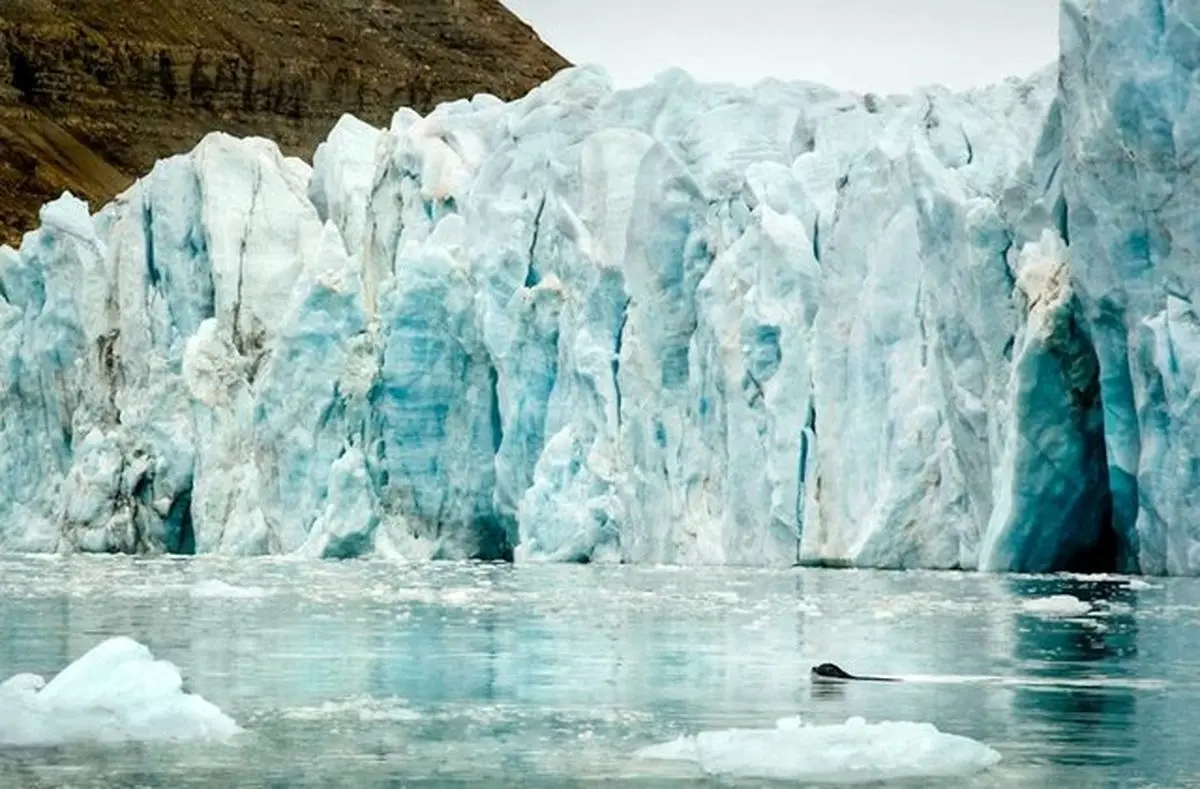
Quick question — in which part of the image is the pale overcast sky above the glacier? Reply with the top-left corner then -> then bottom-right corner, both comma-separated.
502,0 -> 1058,92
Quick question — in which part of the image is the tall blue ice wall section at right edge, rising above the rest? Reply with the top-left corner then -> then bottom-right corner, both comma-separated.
1061,0 -> 1200,574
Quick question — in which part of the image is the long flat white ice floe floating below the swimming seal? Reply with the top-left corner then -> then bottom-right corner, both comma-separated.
637,718 -> 1001,784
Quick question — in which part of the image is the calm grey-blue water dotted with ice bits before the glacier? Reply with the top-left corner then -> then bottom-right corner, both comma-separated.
0,556 -> 1200,789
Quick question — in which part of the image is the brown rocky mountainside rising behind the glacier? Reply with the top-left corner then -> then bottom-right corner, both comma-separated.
0,0 -> 568,243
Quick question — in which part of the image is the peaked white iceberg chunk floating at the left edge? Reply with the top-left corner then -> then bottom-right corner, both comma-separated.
0,636 -> 242,747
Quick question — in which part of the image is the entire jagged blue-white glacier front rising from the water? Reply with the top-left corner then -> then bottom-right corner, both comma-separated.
0,0 -> 1200,574
